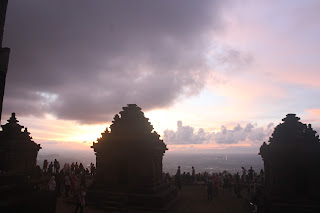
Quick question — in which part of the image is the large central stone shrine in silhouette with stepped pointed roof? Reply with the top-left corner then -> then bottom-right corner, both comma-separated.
92,104 -> 177,210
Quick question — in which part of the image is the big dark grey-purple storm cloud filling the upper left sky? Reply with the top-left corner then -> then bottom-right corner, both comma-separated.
4,0 -> 228,123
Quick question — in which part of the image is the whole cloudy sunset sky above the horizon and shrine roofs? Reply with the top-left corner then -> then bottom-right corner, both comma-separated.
1,0 -> 320,153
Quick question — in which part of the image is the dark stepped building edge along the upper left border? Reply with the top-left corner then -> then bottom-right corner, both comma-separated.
0,0 -> 10,124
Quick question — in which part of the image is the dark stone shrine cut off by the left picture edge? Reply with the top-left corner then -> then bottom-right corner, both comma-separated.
0,113 -> 41,174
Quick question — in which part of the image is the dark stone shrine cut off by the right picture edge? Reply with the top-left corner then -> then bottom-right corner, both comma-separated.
259,114 -> 320,213
